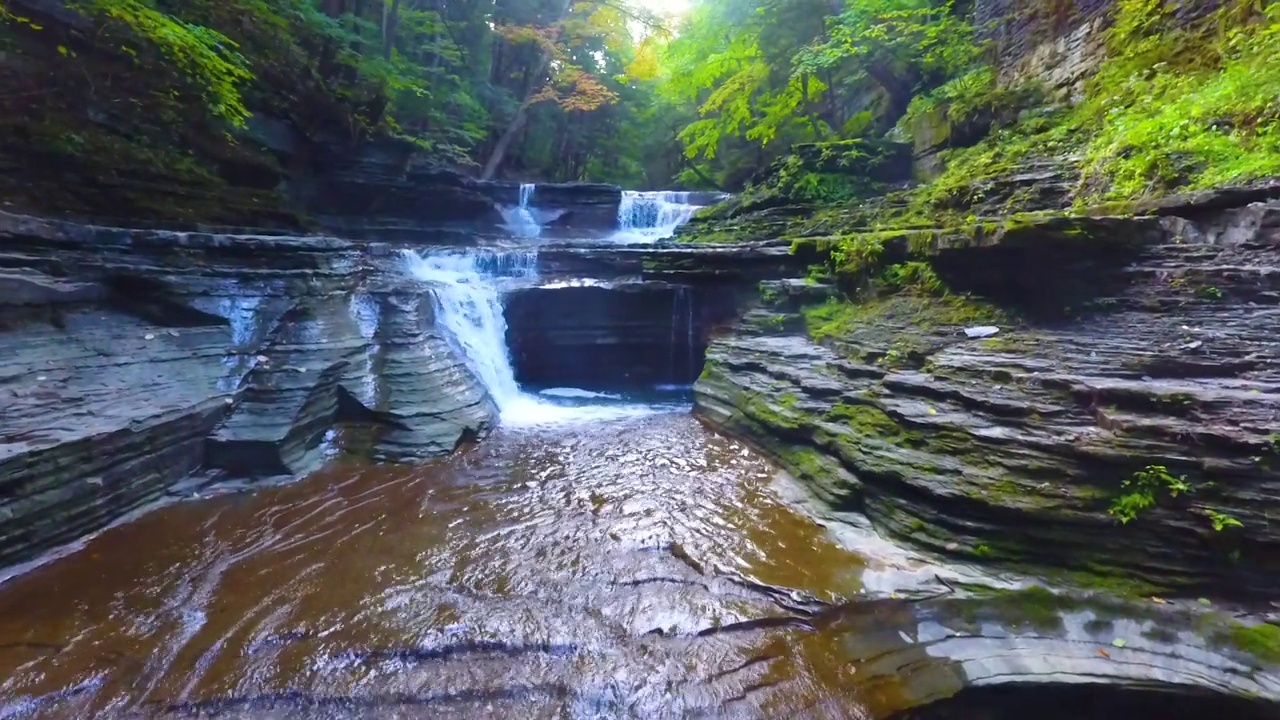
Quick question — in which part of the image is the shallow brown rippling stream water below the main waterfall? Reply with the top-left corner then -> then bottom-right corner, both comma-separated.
0,414 -> 885,717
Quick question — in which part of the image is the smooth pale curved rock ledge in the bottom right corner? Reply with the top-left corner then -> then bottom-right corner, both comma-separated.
822,588 -> 1280,720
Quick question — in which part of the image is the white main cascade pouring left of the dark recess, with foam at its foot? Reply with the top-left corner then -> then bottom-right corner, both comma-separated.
403,250 -> 675,425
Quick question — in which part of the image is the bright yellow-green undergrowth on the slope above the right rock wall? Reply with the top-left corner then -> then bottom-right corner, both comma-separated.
918,0 -> 1280,209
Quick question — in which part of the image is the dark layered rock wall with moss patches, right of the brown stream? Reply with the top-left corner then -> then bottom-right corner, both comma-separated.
696,204 -> 1280,598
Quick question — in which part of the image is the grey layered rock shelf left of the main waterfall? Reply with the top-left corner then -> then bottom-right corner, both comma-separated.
0,210 -> 493,565
